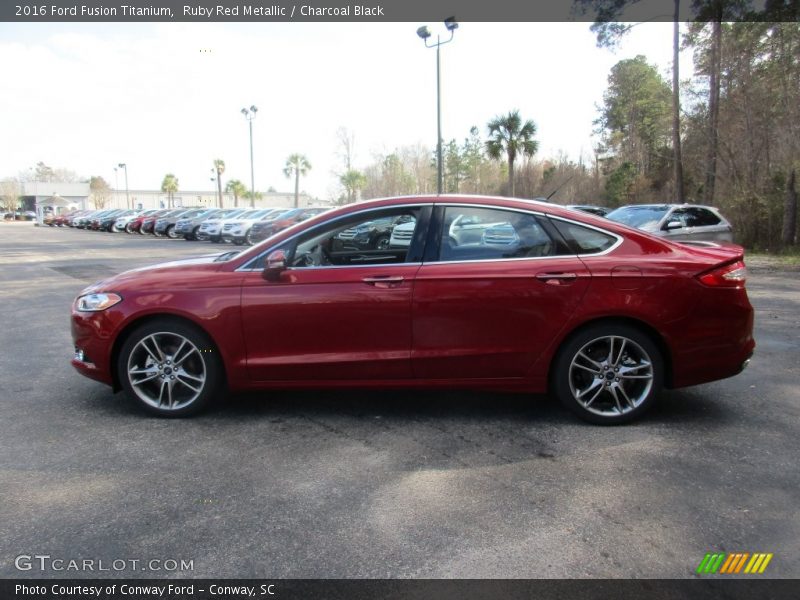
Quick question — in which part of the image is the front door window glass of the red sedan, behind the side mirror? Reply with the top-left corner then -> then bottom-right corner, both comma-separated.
261,207 -> 421,268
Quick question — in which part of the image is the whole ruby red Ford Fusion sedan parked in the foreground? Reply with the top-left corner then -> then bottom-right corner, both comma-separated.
72,196 -> 755,423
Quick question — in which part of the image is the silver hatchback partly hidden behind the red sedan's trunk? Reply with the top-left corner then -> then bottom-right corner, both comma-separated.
606,204 -> 733,242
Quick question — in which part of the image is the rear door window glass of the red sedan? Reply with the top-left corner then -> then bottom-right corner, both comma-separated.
439,206 -> 559,262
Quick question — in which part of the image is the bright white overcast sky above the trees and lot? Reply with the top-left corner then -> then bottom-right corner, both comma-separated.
0,22 -> 692,200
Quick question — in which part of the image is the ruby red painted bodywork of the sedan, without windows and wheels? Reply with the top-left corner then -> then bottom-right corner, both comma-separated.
72,196 -> 755,404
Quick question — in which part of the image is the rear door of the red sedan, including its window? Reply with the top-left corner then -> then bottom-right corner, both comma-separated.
412,204 -> 590,379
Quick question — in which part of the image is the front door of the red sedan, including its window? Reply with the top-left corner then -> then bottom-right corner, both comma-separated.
242,207 -> 422,381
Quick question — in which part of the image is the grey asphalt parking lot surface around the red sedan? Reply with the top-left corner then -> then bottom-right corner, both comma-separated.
0,223 -> 800,578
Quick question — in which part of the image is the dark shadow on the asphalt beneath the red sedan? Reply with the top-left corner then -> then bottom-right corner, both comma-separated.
85,388 -> 736,427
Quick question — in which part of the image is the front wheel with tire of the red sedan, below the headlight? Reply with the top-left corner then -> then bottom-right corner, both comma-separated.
116,318 -> 223,417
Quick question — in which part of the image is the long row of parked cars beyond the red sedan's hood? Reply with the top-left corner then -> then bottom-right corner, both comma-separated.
45,207 -> 327,246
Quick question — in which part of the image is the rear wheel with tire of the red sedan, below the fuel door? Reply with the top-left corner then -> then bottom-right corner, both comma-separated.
551,323 -> 664,425
